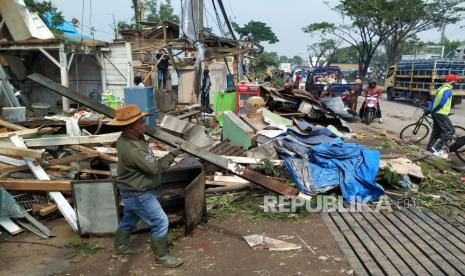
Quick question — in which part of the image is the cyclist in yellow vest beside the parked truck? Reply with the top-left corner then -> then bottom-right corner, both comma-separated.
427,74 -> 460,159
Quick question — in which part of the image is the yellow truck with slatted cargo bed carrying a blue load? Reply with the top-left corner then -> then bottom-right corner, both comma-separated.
384,60 -> 465,106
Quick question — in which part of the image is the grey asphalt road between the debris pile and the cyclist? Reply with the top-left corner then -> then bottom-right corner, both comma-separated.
359,97 -> 465,140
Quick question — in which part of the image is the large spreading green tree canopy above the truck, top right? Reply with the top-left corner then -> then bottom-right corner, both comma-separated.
303,0 -> 463,77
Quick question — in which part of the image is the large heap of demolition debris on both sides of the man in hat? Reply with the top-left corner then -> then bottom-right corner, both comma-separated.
0,74 -> 456,243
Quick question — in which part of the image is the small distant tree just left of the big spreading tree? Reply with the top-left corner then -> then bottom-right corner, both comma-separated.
307,38 -> 340,67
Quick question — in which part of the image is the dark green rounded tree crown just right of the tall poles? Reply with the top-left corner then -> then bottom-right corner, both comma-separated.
232,20 -> 279,44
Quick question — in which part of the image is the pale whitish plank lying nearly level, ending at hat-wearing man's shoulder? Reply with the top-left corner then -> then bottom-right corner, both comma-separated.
24,132 -> 121,147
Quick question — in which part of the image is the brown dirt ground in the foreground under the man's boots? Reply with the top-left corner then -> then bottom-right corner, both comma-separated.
0,211 -> 351,275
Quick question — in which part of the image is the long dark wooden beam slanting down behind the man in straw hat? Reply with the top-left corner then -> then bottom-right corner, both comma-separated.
28,73 -> 299,196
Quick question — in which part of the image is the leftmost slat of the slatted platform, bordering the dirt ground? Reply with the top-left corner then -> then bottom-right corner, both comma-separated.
321,213 -> 368,275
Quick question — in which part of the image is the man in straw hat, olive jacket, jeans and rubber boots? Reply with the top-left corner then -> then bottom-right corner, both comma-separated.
108,105 -> 183,267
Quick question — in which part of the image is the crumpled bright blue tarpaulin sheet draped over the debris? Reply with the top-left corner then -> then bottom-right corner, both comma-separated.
285,138 -> 384,202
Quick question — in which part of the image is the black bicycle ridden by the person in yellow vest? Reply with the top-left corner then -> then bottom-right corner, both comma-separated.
400,109 -> 465,162
